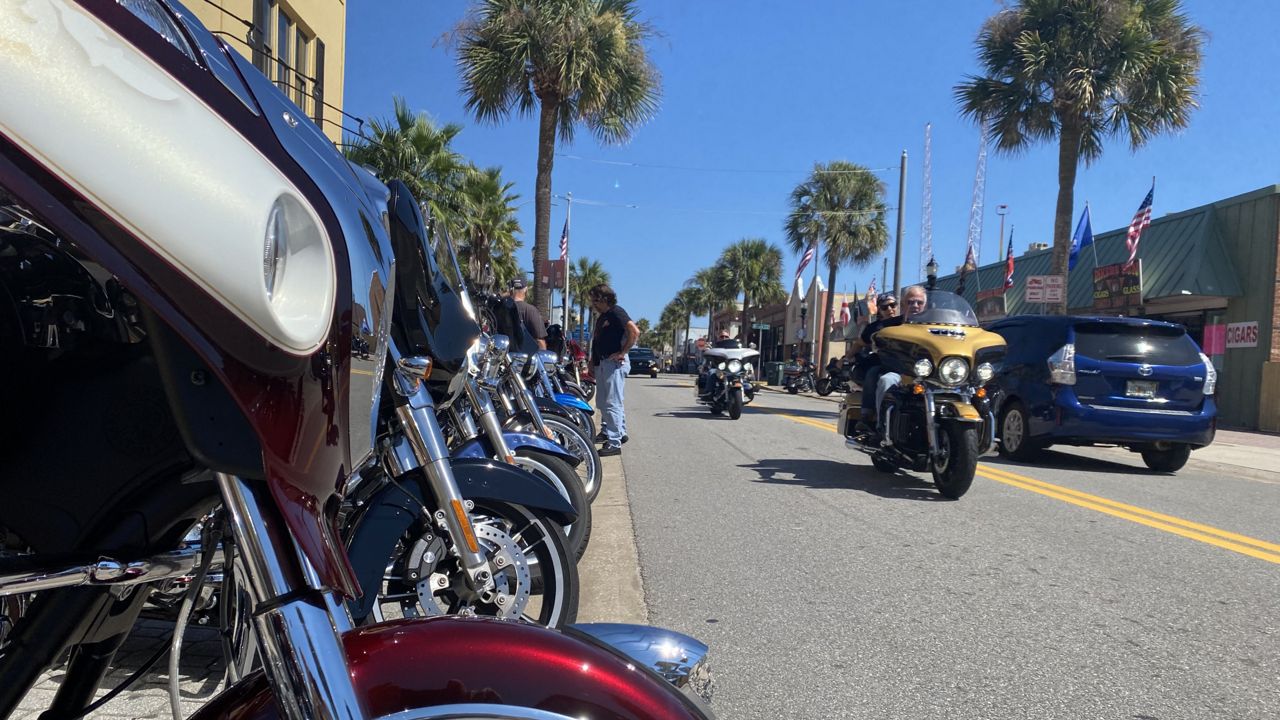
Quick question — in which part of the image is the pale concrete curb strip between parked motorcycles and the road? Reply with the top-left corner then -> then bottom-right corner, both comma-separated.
577,455 -> 649,625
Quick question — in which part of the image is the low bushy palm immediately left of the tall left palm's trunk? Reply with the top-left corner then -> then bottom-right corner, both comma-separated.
451,165 -> 520,290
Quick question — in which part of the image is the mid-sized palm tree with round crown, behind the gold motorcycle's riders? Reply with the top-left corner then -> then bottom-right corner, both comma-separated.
786,160 -> 888,373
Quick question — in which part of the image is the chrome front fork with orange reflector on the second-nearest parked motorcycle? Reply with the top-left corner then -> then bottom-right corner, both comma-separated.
393,357 -> 493,592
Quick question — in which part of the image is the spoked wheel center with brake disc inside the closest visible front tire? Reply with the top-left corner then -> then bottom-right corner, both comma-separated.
408,523 -> 532,619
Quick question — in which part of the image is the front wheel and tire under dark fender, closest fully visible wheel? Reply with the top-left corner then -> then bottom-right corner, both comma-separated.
352,500 -> 579,628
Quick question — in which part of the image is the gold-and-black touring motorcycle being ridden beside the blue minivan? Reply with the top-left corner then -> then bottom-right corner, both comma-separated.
838,290 -> 1005,500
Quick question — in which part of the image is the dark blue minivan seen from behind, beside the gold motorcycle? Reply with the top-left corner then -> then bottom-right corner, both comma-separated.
987,315 -> 1217,473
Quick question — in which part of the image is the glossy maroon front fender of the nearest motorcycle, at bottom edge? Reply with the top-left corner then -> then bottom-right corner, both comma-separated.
193,609 -> 703,720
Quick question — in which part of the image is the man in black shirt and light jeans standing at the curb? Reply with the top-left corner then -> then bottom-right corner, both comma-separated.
589,283 -> 640,456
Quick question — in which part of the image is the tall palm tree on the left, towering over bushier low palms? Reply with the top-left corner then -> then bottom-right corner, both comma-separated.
458,0 -> 659,314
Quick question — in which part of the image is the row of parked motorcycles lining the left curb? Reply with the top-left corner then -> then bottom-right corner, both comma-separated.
0,0 -> 710,720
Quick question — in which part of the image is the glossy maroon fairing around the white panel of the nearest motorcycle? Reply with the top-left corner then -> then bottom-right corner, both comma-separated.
0,1 -> 360,597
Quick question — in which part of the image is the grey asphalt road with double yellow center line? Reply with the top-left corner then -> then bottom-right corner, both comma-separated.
623,375 -> 1280,720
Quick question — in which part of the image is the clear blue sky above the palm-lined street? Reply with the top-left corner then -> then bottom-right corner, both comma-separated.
344,0 -> 1280,320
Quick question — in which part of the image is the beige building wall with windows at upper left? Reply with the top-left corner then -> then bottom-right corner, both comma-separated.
184,0 -> 347,142
